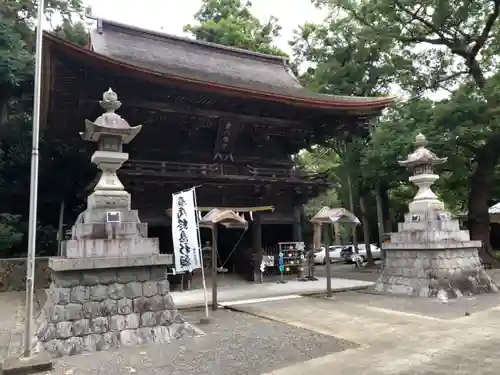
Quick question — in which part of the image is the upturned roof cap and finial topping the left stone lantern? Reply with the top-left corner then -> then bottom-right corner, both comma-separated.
80,88 -> 142,144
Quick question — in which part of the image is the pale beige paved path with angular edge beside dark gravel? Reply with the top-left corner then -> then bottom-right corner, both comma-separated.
230,293 -> 500,375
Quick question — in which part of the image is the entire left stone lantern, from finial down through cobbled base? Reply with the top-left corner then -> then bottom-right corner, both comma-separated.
30,89 -> 191,357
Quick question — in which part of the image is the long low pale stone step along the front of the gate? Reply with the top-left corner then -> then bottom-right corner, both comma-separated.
172,277 -> 373,309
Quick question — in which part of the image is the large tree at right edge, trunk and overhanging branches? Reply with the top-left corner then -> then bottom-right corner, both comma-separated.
316,0 -> 500,260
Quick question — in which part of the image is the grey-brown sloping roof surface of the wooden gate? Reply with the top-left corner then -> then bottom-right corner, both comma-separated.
86,20 -> 394,108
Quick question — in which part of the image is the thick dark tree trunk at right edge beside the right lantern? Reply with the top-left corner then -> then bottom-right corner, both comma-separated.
467,137 -> 500,263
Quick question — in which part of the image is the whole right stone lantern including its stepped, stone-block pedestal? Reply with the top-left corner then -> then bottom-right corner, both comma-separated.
374,134 -> 498,301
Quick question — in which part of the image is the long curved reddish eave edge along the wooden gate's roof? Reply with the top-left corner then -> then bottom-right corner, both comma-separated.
44,32 -> 396,112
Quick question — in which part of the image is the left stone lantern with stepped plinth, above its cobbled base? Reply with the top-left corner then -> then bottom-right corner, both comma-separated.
62,89 -> 158,258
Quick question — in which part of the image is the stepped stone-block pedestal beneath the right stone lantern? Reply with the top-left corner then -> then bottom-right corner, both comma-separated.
374,211 -> 498,300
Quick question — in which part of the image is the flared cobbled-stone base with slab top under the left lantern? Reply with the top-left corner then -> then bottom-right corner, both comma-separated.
36,255 -> 194,357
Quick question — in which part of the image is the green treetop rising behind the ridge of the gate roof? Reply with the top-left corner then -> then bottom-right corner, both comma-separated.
184,0 -> 284,55
